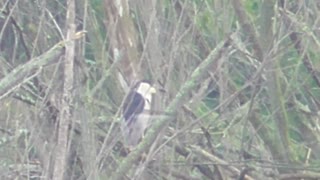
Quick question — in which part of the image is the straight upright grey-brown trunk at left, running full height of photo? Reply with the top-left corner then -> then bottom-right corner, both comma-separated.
53,0 -> 76,180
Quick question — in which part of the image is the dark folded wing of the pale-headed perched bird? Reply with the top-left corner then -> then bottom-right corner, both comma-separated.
123,91 -> 144,121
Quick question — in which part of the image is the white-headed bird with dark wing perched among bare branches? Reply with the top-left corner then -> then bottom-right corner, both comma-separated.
121,81 -> 156,148
